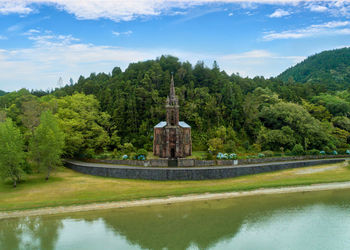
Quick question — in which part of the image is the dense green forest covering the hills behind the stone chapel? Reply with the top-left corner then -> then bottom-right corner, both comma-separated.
0,49 -> 350,160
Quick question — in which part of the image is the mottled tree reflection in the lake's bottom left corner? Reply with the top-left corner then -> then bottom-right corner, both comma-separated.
0,217 -> 62,250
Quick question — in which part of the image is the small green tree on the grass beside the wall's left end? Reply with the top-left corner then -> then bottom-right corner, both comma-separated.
29,111 -> 64,180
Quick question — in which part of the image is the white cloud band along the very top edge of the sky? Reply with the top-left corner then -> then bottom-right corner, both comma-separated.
0,0 -> 350,21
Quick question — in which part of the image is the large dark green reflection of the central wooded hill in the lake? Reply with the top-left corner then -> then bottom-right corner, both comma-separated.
98,189 -> 348,249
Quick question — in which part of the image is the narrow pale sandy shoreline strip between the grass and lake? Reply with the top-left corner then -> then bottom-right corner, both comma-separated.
0,181 -> 350,220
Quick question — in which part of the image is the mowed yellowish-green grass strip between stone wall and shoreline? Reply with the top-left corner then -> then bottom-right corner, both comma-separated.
0,163 -> 350,211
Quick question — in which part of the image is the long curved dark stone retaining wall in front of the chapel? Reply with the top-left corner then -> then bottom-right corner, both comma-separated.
65,159 -> 344,180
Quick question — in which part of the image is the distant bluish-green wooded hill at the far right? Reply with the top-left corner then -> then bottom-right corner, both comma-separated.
278,48 -> 350,90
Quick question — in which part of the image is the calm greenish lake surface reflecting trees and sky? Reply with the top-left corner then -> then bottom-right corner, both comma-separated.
0,190 -> 350,250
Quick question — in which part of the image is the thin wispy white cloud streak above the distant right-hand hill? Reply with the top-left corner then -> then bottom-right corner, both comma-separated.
263,21 -> 350,41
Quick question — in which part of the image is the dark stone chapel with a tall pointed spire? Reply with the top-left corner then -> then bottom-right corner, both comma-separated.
153,76 -> 192,159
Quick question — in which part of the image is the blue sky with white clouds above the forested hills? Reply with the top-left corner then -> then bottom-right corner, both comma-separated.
0,0 -> 350,91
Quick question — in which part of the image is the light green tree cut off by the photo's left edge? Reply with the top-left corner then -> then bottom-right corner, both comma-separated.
0,119 -> 25,187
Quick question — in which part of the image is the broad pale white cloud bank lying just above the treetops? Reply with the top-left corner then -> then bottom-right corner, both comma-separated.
0,31 -> 303,91
